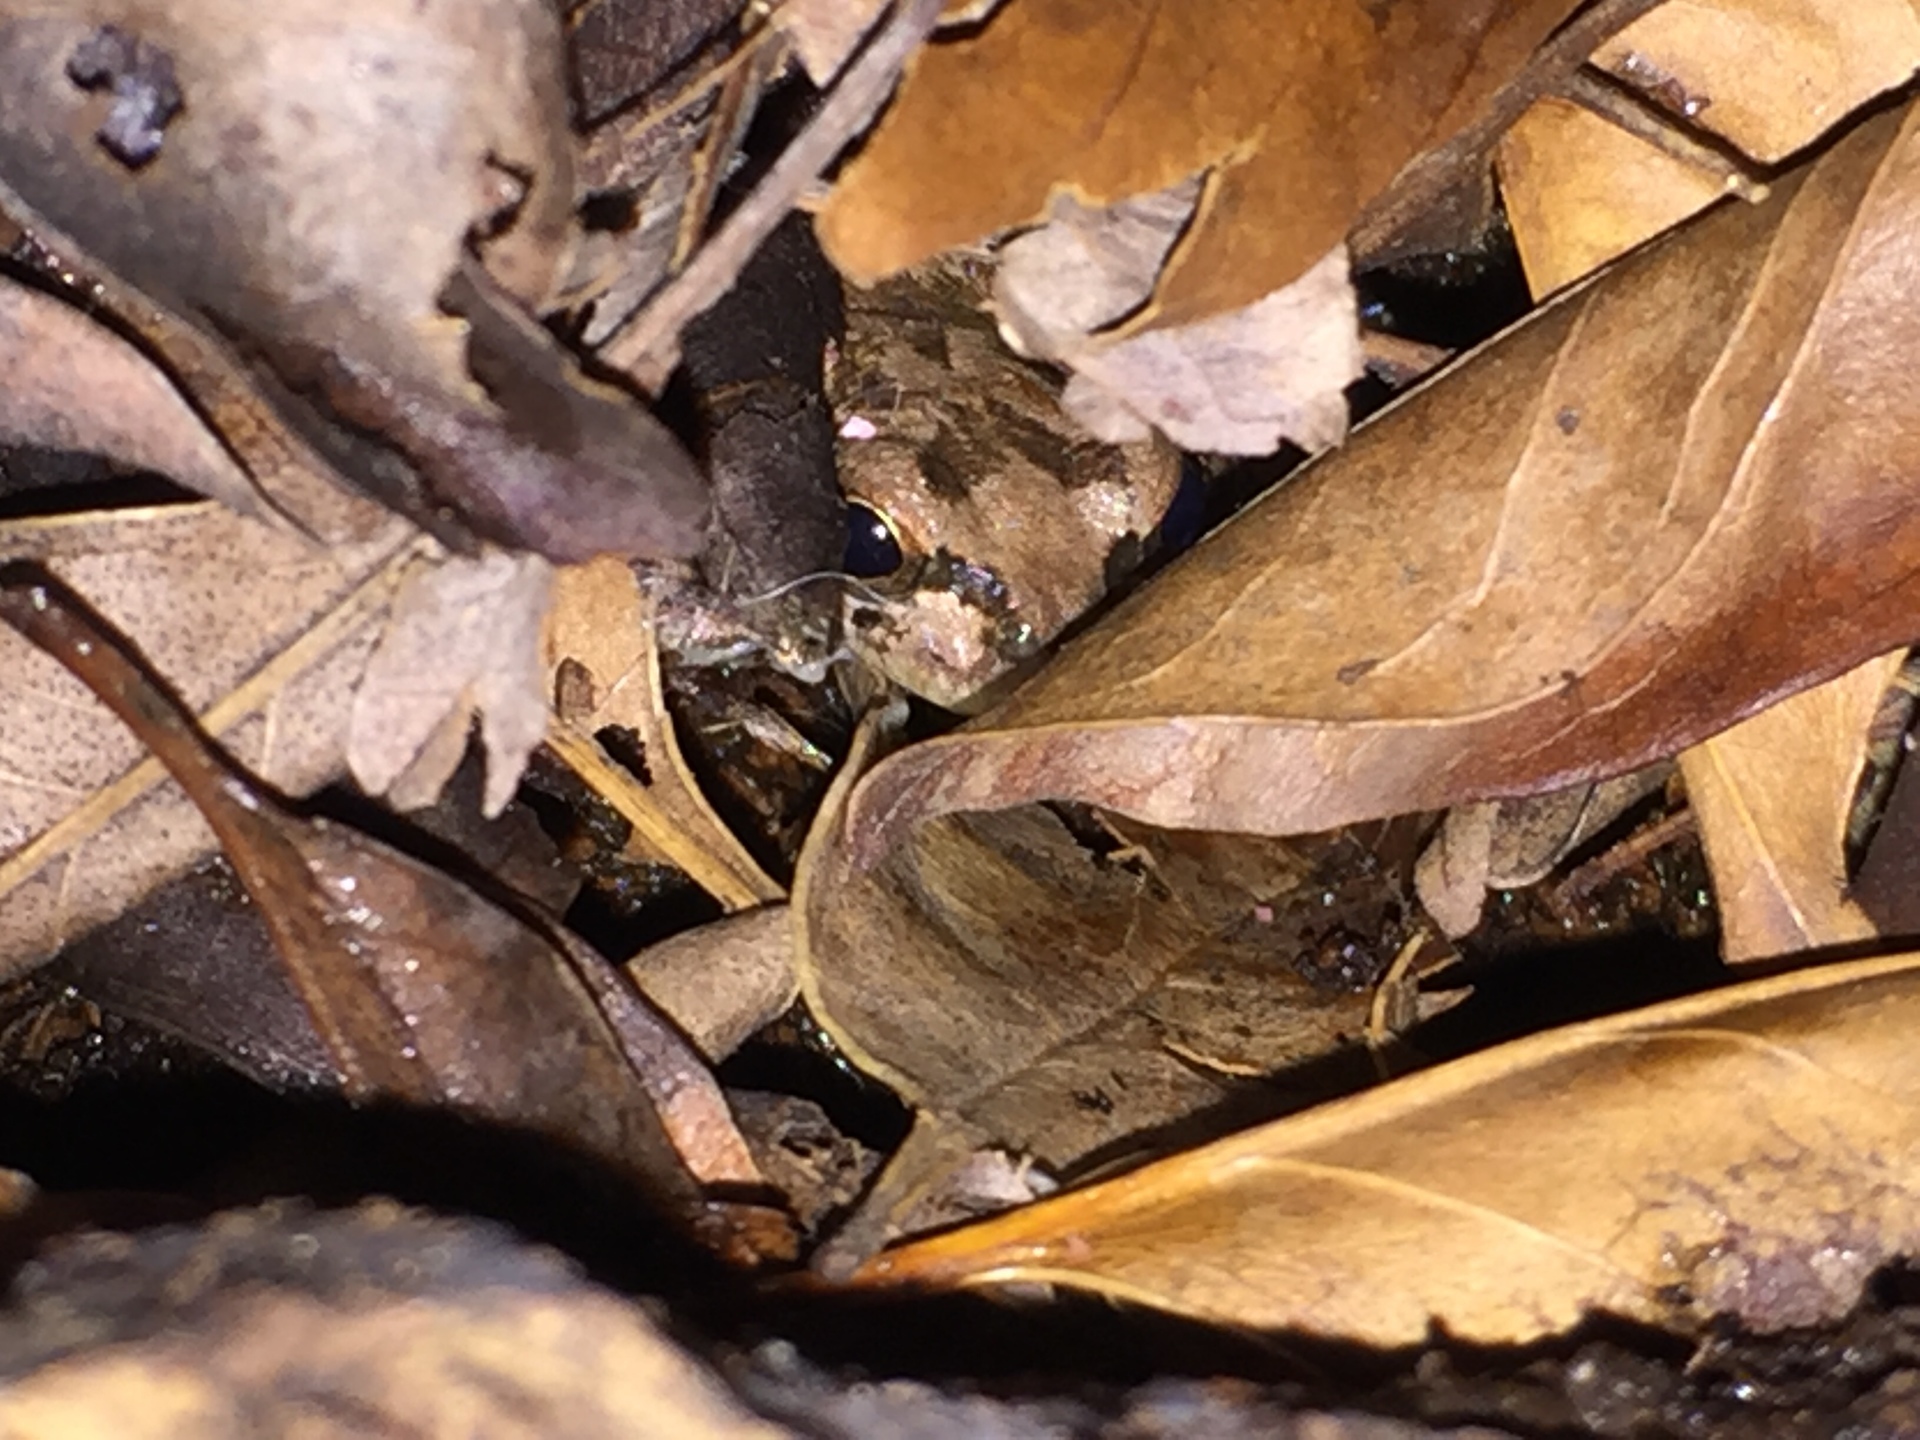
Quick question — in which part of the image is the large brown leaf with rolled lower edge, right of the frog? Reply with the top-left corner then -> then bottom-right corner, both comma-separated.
822,96 -> 1920,868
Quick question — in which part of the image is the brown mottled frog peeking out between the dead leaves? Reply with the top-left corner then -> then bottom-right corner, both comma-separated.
826,252 -> 1181,714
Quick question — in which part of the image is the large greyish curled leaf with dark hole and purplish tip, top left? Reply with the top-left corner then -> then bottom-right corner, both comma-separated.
0,0 -> 707,559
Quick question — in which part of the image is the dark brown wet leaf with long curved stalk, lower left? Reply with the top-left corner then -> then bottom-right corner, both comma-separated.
0,564 -> 791,1261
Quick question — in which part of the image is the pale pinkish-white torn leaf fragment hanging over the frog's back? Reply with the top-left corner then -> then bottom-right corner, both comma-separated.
995,182 -> 1361,455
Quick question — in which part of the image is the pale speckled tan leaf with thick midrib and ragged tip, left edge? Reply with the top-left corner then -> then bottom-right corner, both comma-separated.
0,503 -> 560,973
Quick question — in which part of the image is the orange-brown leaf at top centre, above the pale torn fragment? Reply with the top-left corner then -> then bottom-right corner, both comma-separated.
820,0 -> 1572,324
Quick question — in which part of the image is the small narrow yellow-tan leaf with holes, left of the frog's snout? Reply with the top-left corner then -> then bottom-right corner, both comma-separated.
545,559 -> 787,910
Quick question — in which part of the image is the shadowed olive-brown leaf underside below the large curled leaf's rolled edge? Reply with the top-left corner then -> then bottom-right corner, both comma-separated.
795,720 -> 1411,1265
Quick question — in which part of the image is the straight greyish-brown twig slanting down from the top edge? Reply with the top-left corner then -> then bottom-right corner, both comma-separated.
599,0 -> 941,394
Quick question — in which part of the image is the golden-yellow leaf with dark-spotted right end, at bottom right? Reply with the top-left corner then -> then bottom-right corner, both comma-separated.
858,954 -> 1920,1346
